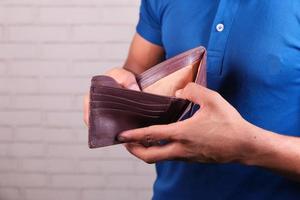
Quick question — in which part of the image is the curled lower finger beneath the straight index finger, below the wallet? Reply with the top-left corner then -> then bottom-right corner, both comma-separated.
125,143 -> 181,164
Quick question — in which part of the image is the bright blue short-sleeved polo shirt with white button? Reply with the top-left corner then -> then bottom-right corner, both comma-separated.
137,0 -> 300,200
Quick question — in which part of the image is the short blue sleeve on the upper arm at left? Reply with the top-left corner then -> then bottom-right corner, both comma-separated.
136,0 -> 162,46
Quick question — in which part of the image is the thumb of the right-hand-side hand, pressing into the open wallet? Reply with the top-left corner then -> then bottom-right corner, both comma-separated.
176,83 -> 216,107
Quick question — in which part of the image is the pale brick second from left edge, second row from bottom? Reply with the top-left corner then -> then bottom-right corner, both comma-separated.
51,174 -> 106,188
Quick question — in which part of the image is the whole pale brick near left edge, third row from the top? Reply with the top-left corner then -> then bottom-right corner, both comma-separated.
7,25 -> 69,42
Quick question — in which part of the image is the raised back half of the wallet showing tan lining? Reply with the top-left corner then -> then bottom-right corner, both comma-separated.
137,48 -> 205,97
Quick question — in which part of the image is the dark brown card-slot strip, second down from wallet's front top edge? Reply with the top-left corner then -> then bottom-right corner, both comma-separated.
92,86 -> 170,104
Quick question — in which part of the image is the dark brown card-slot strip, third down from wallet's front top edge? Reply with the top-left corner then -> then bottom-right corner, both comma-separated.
91,93 -> 170,110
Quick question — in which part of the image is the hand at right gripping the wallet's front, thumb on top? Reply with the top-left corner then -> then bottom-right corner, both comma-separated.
119,83 -> 252,163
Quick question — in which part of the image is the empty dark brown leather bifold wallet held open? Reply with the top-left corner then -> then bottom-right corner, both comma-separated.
89,47 -> 206,148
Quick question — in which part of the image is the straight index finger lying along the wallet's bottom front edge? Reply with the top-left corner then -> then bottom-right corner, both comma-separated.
118,122 -> 181,143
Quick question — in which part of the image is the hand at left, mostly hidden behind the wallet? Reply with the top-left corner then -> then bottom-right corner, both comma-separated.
83,68 -> 140,125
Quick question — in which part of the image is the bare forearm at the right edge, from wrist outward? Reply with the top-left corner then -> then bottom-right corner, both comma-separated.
241,124 -> 300,181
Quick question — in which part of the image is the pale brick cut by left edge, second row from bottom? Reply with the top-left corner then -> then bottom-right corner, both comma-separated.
0,173 -> 47,187
